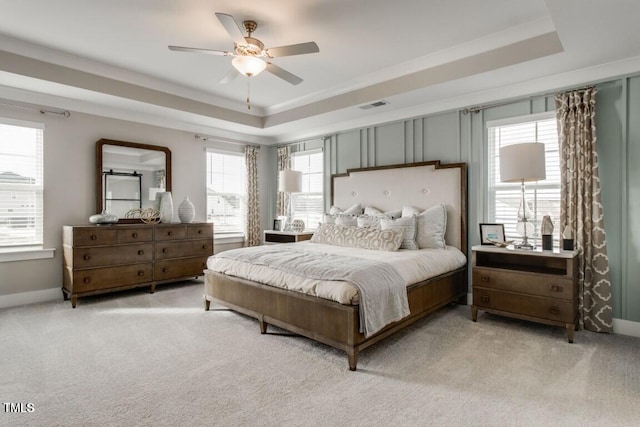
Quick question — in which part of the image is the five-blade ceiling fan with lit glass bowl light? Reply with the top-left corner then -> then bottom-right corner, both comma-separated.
169,12 -> 320,87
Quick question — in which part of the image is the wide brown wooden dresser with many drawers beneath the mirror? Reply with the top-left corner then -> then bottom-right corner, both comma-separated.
62,223 -> 213,308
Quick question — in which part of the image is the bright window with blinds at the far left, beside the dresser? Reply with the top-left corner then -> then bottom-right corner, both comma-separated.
0,119 -> 44,252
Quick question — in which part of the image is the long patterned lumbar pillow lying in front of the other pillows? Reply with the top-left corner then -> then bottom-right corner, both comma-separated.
310,224 -> 403,251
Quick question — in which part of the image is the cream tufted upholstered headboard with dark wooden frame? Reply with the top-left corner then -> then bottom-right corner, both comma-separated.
331,160 -> 467,253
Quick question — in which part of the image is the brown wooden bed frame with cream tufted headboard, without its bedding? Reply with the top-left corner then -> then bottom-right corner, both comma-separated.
204,161 -> 468,371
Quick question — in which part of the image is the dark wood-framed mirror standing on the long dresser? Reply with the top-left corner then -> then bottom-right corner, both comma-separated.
96,139 -> 171,222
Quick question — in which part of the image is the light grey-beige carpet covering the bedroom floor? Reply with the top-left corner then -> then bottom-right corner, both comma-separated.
0,281 -> 640,426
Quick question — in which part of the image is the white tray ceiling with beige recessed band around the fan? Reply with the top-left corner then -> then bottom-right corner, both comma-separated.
0,0 -> 640,143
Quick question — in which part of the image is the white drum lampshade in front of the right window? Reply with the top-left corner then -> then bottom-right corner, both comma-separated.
500,142 -> 547,182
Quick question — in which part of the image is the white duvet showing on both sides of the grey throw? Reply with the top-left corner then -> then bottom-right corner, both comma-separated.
207,242 -> 467,304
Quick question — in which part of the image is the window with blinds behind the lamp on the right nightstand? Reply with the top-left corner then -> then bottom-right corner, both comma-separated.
487,113 -> 560,246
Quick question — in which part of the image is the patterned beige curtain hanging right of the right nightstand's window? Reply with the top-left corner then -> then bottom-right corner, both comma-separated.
555,88 -> 613,332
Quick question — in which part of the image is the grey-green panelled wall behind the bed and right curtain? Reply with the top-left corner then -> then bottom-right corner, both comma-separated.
284,77 -> 640,321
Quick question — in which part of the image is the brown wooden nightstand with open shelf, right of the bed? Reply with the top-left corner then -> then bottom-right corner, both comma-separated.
471,245 -> 578,343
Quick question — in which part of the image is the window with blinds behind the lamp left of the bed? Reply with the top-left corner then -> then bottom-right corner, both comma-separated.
291,151 -> 324,230
